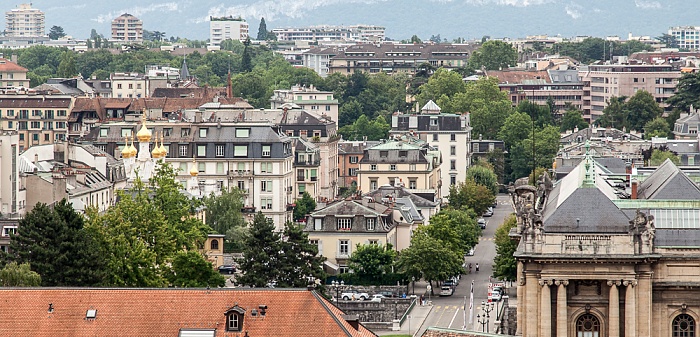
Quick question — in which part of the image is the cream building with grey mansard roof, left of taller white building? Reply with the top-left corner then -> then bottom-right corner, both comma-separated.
357,140 -> 442,198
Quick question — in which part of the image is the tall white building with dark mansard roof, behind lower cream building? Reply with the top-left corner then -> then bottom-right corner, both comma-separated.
389,100 -> 471,197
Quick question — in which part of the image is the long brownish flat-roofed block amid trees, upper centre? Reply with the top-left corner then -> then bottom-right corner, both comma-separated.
328,43 -> 476,75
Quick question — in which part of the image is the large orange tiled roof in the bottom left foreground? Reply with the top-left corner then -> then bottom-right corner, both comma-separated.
0,288 -> 376,337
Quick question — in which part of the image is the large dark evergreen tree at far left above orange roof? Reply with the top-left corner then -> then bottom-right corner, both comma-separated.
6,199 -> 105,287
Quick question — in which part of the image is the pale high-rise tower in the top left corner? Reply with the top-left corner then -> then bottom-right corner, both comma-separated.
5,3 -> 46,38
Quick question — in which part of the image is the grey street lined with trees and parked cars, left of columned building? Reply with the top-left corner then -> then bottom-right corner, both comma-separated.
418,194 -> 513,336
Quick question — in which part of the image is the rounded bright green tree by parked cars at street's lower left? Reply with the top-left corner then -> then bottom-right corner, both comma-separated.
396,233 -> 464,289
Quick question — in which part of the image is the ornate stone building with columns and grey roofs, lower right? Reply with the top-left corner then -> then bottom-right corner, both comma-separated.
511,150 -> 700,337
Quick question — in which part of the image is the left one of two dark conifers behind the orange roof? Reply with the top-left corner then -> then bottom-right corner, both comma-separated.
238,212 -> 282,288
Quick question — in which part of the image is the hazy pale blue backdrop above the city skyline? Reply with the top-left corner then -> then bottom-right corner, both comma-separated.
0,0 -> 700,40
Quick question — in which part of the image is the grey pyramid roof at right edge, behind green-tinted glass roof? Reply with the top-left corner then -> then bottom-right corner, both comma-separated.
637,159 -> 700,200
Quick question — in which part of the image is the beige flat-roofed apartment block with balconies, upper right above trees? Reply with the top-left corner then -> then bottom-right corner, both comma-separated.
579,64 -> 682,121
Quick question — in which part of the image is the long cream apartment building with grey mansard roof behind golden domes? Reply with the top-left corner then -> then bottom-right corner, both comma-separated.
85,120 -> 294,230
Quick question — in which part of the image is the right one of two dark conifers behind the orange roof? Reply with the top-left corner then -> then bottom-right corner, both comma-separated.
275,222 -> 326,288
